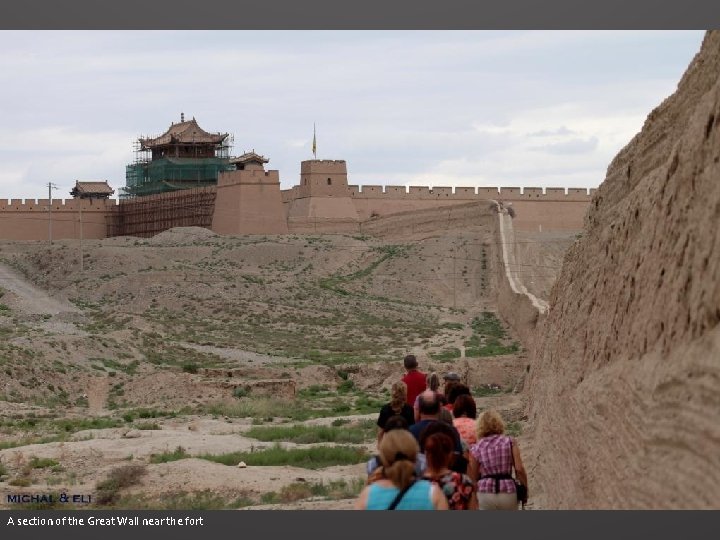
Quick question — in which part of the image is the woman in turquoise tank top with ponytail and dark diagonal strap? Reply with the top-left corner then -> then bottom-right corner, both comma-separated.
355,429 -> 448,510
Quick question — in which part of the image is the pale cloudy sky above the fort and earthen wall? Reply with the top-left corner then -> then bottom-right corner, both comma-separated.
0,30 -> 704,198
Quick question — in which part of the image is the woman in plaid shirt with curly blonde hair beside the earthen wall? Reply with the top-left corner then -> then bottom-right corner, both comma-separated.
469,410 -> 527,510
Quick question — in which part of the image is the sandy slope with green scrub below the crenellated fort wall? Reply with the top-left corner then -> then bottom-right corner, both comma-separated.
0,213 -> 567,508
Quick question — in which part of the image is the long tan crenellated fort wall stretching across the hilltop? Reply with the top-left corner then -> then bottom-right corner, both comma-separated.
0,169 -> 595,240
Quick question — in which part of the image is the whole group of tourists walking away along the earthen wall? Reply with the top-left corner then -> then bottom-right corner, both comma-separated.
356,355 -> 528,510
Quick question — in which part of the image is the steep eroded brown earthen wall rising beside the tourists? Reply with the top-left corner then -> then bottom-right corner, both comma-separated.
528,31 -> 720,508
